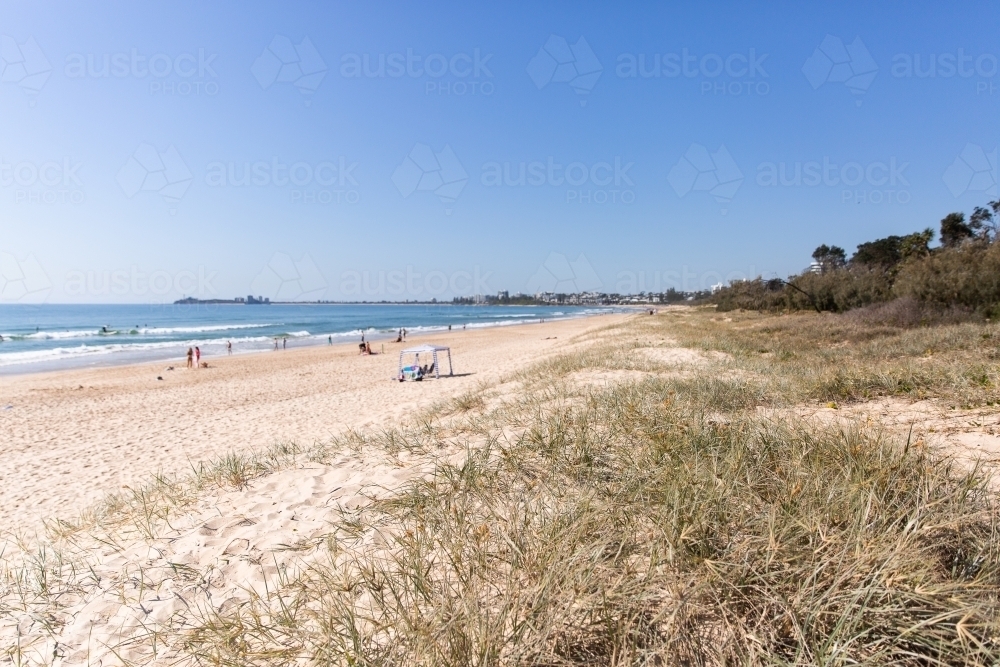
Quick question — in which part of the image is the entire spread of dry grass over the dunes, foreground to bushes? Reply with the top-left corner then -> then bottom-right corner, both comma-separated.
1,311 -> 1000,665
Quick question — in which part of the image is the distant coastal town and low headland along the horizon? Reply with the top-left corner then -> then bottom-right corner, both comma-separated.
174,288 -> 714,306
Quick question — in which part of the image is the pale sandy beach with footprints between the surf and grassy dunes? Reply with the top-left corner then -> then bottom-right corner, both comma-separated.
0,315 -> 627,531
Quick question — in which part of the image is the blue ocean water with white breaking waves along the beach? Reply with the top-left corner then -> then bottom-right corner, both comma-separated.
0,304 -> 611,374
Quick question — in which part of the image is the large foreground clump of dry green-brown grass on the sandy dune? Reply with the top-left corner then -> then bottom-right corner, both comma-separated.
174,382 -> 1000,665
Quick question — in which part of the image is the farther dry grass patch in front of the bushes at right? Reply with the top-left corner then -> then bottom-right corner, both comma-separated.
660,313 -> 1000,407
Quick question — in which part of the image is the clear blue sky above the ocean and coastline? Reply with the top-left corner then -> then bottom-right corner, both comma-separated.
0,0 -> 1000,302
